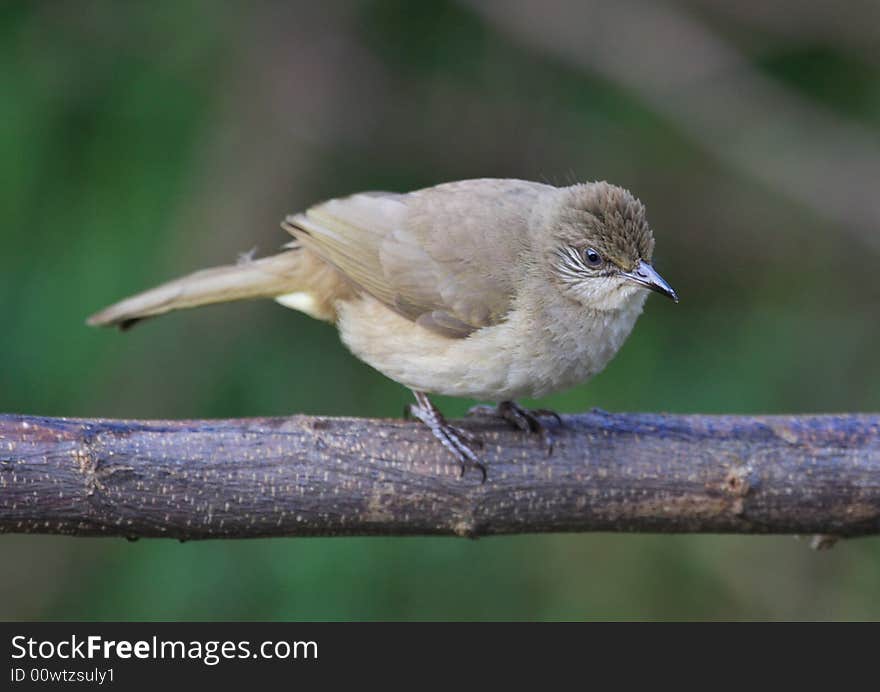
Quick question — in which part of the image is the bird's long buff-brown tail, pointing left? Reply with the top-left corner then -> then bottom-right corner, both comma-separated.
87,248 -> 302,329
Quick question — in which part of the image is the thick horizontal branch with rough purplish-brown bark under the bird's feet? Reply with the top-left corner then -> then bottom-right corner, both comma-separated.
0,412 -> 880,539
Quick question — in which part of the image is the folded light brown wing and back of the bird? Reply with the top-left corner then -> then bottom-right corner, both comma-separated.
285,179 -> 545,337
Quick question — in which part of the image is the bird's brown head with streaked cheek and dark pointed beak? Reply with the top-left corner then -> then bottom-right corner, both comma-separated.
545,182 -> 678,310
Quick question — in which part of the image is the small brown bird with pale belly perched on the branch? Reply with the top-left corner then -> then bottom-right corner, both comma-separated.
87,178 -> 678,481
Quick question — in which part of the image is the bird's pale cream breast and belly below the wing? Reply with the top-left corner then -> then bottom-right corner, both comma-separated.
337,293 -> 645,401
